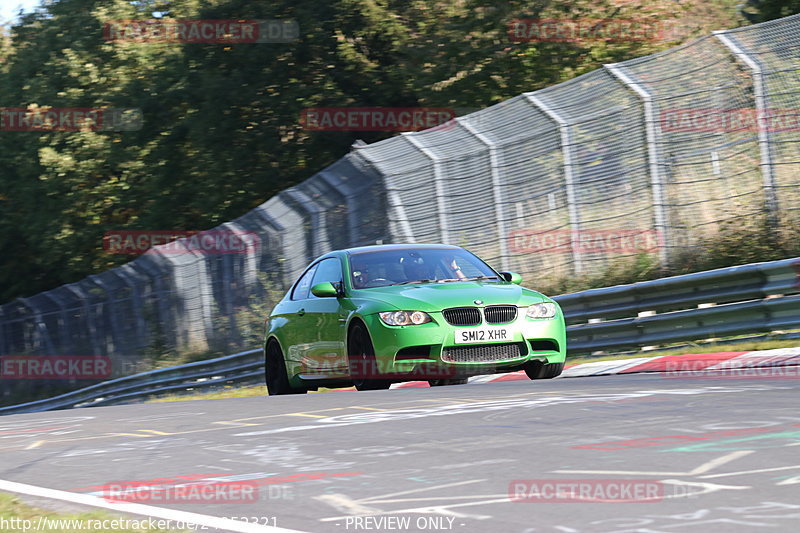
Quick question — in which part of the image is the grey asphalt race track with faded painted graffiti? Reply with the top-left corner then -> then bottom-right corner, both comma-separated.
0,374 -> 800,533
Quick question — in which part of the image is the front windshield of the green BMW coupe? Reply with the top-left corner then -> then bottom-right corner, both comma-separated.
350,248 -> 500,289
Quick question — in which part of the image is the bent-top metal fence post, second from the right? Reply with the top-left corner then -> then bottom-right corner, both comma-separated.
603,64 -> 670,269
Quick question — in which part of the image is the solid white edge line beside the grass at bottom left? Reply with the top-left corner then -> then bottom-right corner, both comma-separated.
0,479 -> 303,533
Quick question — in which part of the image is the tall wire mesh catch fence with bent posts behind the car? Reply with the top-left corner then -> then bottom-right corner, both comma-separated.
0,15 -> 800,402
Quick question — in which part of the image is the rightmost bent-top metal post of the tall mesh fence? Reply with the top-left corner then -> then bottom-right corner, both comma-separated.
713,30 -> 778,227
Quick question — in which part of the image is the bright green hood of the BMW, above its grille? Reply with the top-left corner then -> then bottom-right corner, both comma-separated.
353,281 -> 546,312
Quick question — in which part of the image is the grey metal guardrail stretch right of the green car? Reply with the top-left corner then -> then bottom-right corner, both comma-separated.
554,258 -> 800,353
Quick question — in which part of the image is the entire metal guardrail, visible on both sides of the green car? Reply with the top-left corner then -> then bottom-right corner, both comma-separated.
0,258 -> 800,415
